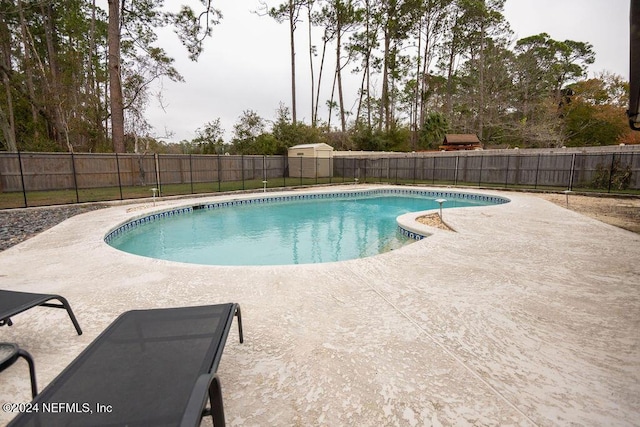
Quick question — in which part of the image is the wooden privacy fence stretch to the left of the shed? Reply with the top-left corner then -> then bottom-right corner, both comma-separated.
0,153 -> 284,192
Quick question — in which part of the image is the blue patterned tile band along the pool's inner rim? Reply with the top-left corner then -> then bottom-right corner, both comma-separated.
104,188 -> 510,244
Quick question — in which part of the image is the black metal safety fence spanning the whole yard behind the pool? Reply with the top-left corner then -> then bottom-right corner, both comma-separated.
0,152 -> 640,208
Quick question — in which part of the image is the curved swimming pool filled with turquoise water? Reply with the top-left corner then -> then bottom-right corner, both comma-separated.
105,189 -> 508,265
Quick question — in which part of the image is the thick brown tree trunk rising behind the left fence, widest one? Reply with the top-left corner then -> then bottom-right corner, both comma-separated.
107,0 -> 126,153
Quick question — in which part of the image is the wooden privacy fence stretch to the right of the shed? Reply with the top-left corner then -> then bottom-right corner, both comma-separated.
334,152 -> 640,193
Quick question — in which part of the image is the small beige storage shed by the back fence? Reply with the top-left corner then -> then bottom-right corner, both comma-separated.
288,143 -> 333,178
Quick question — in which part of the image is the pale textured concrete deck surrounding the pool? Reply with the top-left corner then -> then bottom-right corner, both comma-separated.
0,185 -> 640,426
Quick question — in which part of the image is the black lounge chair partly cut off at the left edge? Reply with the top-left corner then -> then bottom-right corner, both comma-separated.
0,290 -> 82,335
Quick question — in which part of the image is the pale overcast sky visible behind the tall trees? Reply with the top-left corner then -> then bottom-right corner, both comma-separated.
142,0 -> 629,142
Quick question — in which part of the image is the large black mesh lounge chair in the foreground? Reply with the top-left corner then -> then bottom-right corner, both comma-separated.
9,304 -> 243,427
